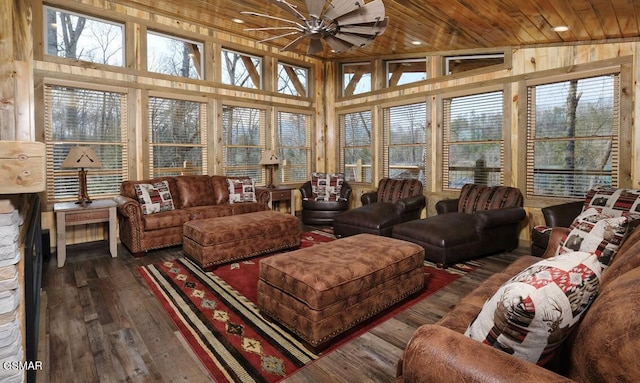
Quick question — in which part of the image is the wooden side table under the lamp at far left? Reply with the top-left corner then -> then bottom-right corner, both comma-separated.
53,200 -> 118,267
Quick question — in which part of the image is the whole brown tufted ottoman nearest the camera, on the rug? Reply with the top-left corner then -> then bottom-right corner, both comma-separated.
258,234 -> 425,351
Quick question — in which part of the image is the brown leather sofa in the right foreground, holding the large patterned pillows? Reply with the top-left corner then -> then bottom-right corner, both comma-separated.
396,228 -> 640,383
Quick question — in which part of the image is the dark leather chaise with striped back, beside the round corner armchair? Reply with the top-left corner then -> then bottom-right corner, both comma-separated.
333,178 -> 426,237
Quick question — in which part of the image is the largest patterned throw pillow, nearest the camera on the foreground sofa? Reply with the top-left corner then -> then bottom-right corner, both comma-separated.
465,252 -> 602,365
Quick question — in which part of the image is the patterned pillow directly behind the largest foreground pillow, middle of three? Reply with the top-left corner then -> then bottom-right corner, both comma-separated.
556,208 -> 629,267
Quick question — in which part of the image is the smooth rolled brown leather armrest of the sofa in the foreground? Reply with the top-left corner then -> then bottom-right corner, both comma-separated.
396,324 -> 572,383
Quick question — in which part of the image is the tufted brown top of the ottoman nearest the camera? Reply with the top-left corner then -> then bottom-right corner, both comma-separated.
260,234 -> 424,310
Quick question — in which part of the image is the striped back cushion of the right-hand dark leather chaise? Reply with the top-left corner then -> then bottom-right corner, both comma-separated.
458,184 -> 522,214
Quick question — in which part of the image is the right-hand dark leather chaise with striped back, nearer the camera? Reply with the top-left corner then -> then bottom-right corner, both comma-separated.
392,184 -> 526,266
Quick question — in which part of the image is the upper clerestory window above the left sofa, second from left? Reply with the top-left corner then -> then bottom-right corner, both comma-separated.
147,32 -> 203,79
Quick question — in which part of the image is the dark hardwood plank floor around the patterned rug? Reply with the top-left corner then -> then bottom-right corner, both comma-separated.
39,227 -> 525,383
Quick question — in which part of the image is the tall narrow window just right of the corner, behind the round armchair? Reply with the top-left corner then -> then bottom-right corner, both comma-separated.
340,111 -> 372,182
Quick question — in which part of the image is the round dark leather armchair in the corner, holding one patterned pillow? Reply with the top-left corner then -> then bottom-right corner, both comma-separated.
300,181 -> 351,225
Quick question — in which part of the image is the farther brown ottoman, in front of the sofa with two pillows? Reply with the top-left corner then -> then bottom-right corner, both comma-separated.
182,210 -> 300,269
